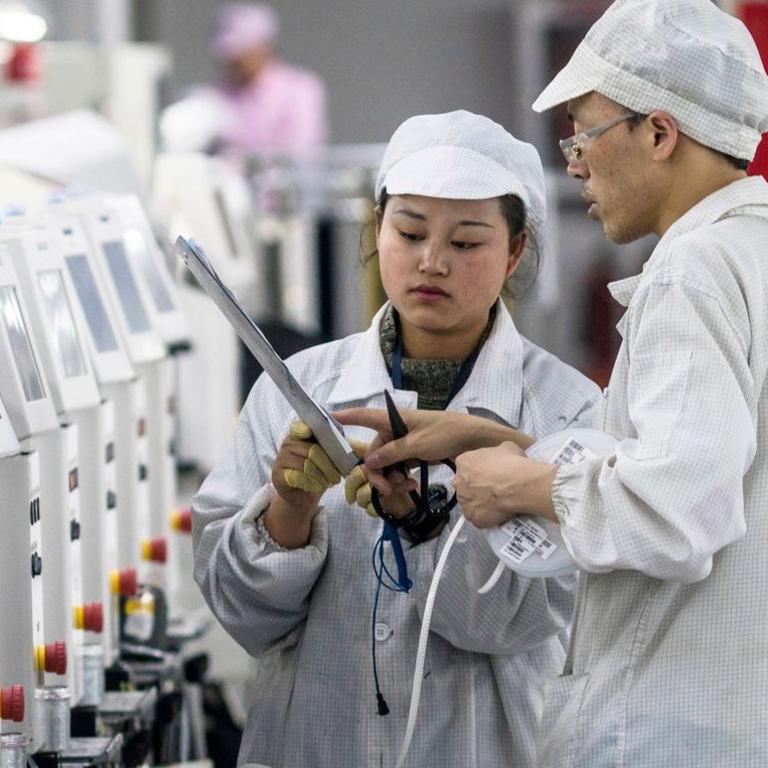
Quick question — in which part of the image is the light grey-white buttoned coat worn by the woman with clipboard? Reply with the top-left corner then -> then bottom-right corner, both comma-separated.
193,304 -> 601,768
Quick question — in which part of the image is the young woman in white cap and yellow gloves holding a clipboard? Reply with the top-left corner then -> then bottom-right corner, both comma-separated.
193,112 -> 600,768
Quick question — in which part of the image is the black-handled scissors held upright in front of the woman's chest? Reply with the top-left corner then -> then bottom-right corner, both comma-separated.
371,391 -> 457,543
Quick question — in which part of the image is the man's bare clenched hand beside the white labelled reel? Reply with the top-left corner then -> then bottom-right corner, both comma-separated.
453,442 -> 557,528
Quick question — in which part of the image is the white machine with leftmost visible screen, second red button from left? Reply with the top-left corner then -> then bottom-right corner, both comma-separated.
0,252 -> 70,751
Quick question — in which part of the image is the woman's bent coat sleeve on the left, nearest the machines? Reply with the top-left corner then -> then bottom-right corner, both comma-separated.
192,376 -> 327,656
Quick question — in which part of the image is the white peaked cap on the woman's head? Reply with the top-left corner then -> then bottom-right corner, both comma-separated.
376,110 -> 547,254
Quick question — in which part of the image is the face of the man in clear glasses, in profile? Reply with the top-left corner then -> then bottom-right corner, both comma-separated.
568,91 -> 658,243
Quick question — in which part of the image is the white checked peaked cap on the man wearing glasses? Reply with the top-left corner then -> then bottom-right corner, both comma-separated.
533,0 -> 768,160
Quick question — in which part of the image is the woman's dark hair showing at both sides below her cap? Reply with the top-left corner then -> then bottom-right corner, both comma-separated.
360,189 -> 540,296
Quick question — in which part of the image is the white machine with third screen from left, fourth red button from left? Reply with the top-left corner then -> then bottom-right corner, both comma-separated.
47,214 -> 148,616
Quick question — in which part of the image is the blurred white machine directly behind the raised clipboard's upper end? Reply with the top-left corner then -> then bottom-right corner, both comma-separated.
153,154 -> 255,472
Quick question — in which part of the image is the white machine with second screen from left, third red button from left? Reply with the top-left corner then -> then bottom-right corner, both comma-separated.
0,219 -> 117,703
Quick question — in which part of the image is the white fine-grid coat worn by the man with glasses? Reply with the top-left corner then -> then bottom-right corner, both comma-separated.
541,178 -> 768,768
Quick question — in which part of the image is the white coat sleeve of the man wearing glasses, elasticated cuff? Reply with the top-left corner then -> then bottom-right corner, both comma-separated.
552,279 -> 756,582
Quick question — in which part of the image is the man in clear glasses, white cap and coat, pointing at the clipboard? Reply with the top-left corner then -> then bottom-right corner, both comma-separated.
340,0 -> 768,768
